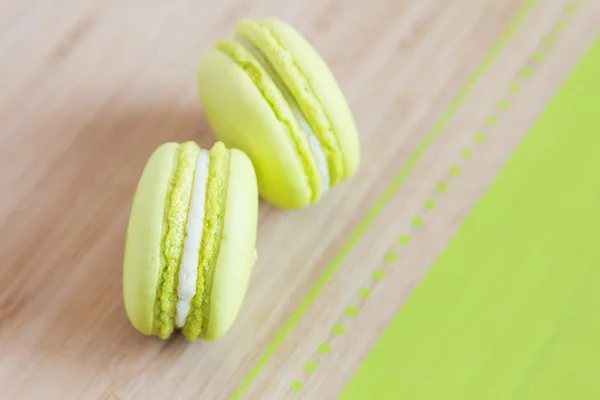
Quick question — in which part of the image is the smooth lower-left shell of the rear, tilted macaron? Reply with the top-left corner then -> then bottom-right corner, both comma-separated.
198,49 -> 311,208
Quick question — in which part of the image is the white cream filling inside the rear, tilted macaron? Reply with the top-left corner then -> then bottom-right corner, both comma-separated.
235,36 -> 331,196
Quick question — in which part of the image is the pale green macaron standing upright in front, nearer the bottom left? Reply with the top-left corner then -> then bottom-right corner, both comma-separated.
123,142 -> 258,341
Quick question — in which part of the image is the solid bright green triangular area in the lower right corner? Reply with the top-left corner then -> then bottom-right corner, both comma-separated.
340,35 -> 600,400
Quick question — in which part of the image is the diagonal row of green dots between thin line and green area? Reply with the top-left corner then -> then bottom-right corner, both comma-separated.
289,4 -> 579,393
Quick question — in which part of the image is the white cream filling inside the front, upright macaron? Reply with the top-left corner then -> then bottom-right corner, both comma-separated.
175,150 -> 210,328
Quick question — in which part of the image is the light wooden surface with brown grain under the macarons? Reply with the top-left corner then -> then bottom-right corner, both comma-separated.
0,0 -> 600,400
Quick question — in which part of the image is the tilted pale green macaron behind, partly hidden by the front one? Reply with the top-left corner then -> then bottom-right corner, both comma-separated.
198,18 -> 360,209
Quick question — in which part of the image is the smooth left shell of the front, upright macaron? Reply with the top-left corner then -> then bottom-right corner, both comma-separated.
123,143 -> 179,335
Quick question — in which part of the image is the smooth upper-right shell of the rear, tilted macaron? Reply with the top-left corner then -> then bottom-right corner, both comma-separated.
257,18 -> 360,179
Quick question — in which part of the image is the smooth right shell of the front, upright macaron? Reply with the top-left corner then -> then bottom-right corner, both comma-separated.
204,149 -> 258,341
